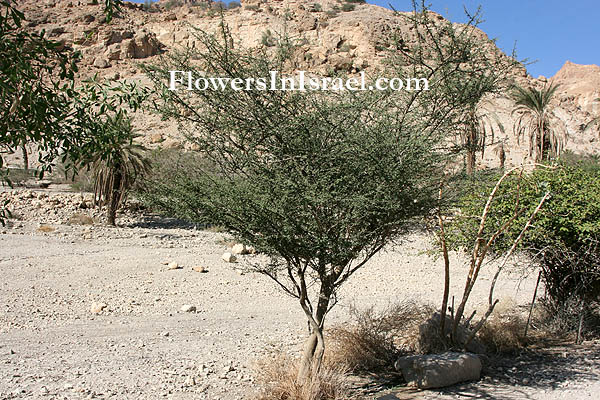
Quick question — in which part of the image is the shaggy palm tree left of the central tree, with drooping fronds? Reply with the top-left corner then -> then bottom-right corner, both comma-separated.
87,114 -> 150,226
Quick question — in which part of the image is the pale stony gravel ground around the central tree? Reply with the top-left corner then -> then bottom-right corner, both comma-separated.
0,189 -> 600,399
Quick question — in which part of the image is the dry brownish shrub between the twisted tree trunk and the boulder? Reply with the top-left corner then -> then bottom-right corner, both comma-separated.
326,302 -> 439,373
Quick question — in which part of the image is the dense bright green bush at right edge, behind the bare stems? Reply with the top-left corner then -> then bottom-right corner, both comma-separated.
449,163 -> 600,304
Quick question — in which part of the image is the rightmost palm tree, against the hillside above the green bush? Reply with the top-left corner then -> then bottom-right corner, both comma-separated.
512,83 -> 567,162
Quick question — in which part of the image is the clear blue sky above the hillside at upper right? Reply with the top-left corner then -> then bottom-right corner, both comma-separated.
129,0 -> 600,77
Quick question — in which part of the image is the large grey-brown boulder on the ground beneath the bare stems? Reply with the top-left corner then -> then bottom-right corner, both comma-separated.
395,352 -> 481,389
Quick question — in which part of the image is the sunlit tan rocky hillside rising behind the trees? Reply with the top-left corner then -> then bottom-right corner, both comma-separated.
12,0 -> 600,170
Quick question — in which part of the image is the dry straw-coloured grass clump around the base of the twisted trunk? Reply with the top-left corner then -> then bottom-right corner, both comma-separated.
255,354 -> 350,400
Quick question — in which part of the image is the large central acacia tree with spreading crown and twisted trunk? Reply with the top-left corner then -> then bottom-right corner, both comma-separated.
146,0 -> 508,383
